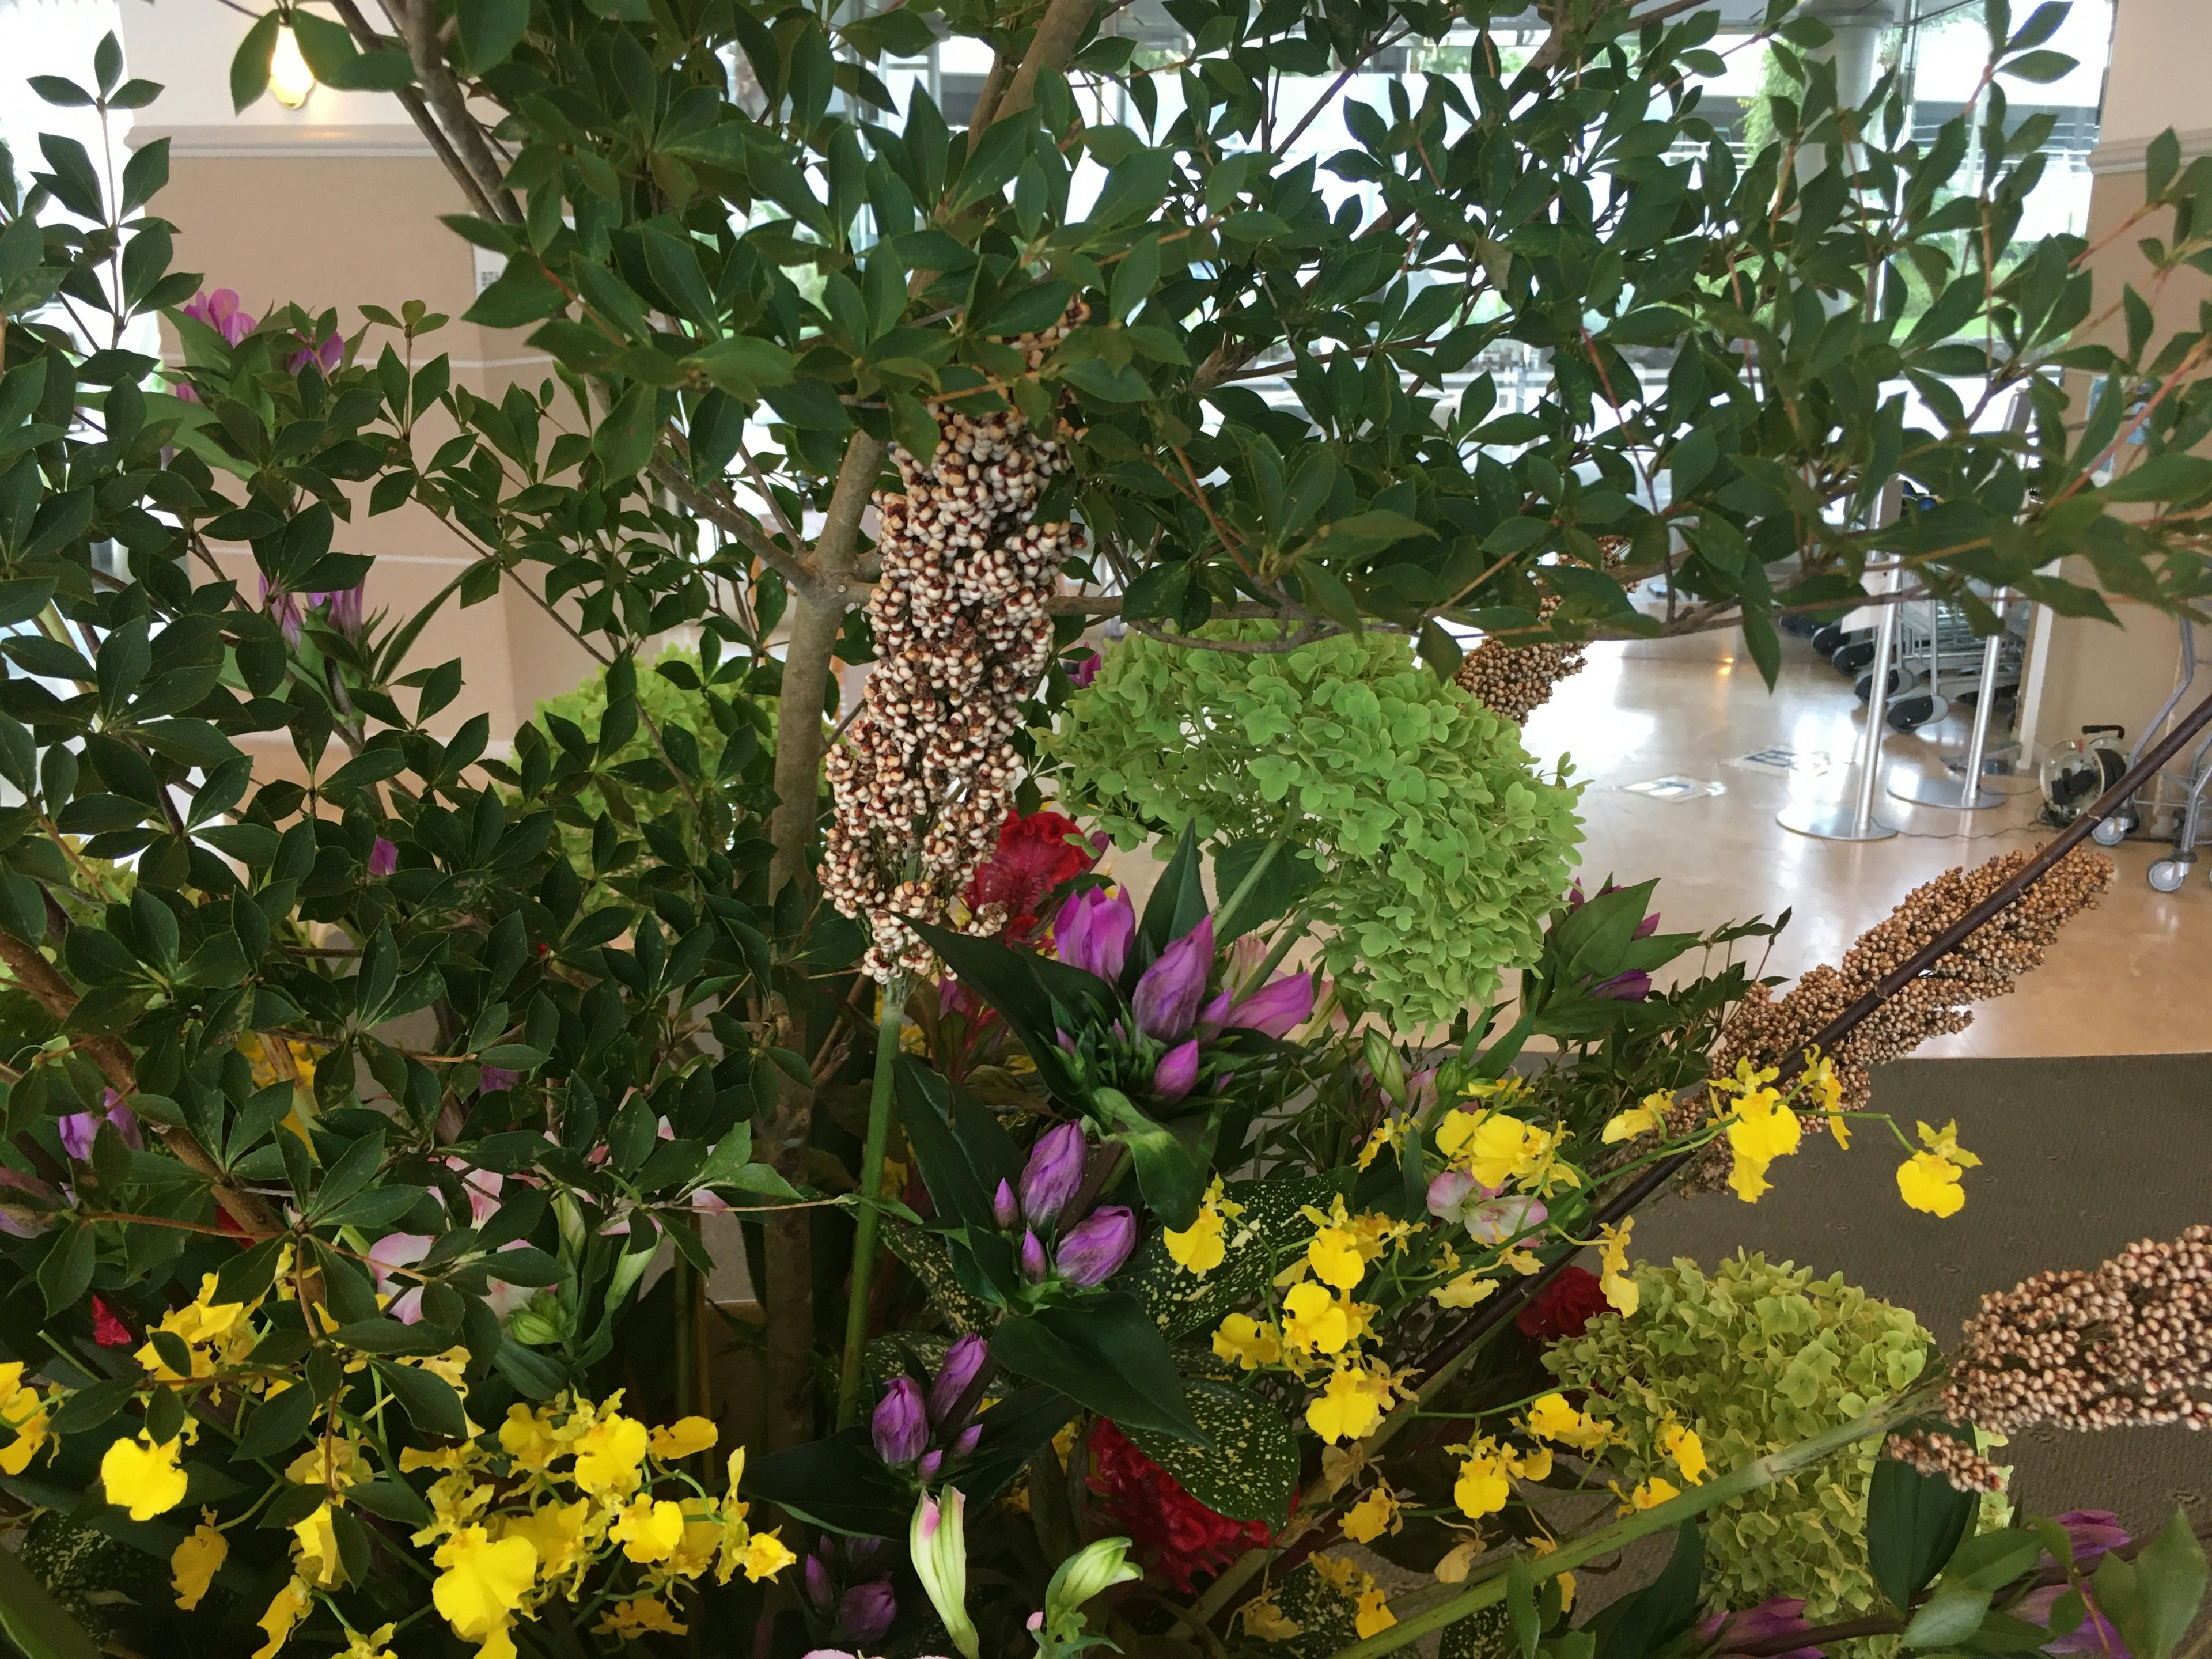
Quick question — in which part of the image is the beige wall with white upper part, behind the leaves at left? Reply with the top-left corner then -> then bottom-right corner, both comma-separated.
124,0 -> 590,778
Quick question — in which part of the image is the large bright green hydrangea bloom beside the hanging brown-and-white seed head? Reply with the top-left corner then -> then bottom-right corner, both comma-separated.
1040,624 -> 1582,1029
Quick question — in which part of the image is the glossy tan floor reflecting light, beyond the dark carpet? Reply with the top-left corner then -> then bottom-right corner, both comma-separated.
1527,635 -> 2212,1058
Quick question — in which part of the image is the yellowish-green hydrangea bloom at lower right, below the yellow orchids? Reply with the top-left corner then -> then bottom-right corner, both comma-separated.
1544,1256 -> 1929,1624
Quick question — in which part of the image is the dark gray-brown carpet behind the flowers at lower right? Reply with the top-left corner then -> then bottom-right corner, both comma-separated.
1635,1055 -> 2212,1535
